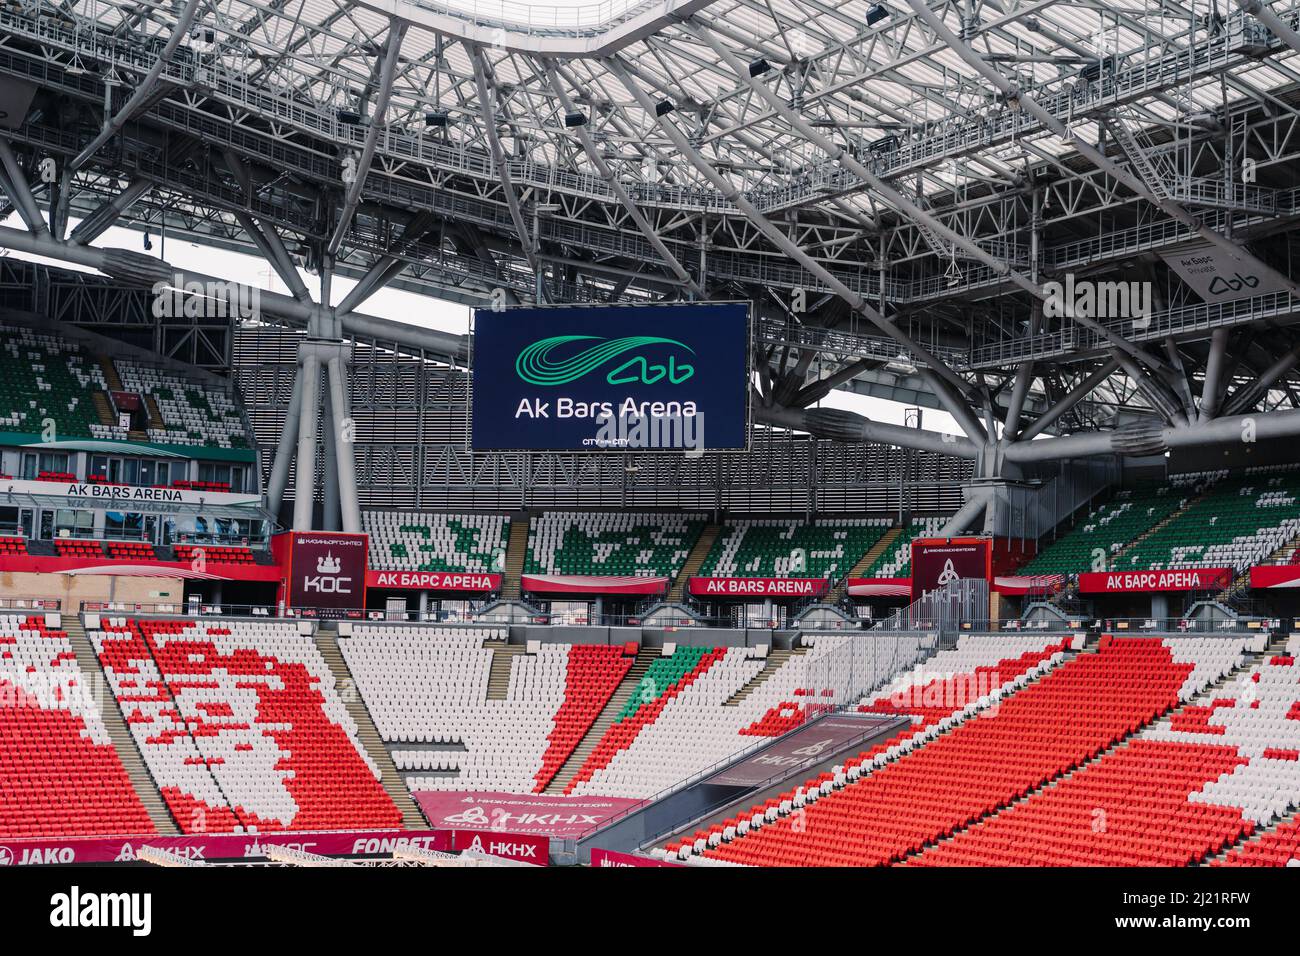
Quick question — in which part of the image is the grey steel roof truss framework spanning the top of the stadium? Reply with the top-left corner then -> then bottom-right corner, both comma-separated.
0,0 -> 1300,525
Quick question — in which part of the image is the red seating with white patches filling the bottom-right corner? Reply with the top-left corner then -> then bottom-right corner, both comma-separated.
917,639 -> 1300,866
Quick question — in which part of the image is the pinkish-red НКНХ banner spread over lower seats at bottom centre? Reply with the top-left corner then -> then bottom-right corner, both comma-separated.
411,790 -> 641,840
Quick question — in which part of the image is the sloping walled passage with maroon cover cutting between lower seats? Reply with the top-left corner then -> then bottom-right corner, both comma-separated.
569,710 -> 910,865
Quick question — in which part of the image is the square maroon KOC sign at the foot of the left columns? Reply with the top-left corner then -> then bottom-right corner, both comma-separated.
272,531 -> 369,618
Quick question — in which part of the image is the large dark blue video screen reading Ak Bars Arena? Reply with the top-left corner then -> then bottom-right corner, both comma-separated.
471,303 -> 749,451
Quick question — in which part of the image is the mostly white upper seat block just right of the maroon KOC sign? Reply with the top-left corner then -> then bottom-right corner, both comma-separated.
361,511 -> 510,574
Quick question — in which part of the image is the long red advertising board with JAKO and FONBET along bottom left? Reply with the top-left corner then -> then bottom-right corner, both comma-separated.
0,830 -> 452,866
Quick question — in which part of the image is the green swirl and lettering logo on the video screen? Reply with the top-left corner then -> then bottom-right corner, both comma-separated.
515,336 -> 696,385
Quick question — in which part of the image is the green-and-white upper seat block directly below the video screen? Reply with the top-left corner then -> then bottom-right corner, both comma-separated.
524,511 -> 705,578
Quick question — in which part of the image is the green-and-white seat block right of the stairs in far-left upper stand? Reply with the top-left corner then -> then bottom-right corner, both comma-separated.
113,359 -> 250,449
